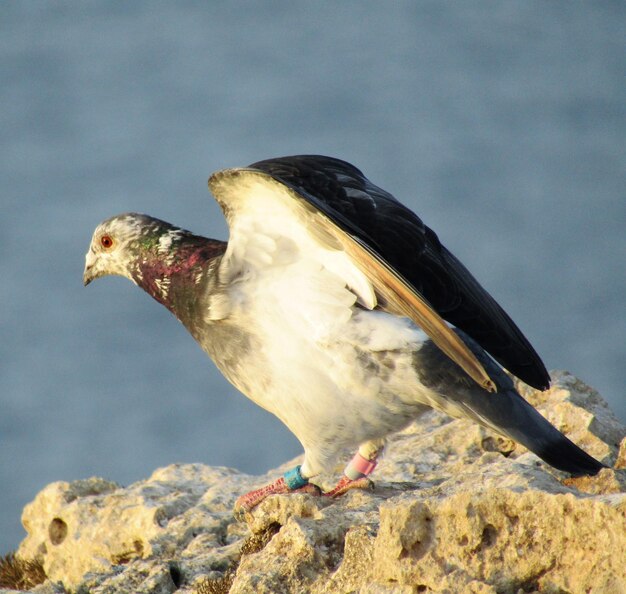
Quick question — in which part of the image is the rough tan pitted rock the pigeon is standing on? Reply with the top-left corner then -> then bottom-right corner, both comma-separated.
0,372 -> 626,594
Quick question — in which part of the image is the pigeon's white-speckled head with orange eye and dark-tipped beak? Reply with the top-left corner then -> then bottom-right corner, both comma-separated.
83,213 -> 170,286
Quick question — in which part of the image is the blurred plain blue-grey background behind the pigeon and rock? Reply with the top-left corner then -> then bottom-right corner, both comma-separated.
0,0 -> 626,553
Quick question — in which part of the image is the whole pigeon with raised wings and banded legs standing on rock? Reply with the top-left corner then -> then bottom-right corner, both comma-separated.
83,155 -> 604,513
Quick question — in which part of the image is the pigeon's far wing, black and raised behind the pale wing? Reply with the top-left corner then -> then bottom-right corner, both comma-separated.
250,155 -> 550,390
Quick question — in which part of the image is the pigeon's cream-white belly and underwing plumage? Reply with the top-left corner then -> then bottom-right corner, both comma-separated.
202,171 -> 442,464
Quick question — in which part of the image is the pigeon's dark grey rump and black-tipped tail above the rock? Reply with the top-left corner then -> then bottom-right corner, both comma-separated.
422,332 -> 605,476
